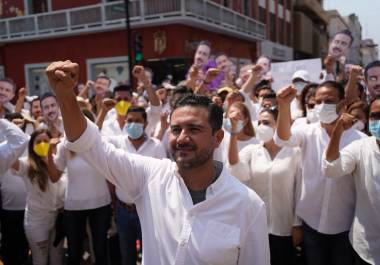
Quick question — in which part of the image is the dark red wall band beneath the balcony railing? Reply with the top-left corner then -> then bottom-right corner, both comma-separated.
2,25 -> 255,86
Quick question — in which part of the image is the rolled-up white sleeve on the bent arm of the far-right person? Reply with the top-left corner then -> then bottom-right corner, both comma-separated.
322,141 -> 360,178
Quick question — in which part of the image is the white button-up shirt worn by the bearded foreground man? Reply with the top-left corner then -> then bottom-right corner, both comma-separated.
66,119 -> 270,265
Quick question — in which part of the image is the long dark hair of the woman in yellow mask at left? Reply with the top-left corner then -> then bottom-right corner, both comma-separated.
28,129 -> 52,191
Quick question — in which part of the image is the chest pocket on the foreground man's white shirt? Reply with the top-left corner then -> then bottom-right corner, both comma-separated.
199,221 -> 240,265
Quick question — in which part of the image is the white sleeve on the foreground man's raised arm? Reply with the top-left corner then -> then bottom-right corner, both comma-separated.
65,118 -> 160,202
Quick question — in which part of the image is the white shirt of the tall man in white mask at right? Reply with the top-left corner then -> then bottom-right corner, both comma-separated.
274,122 -> 366,234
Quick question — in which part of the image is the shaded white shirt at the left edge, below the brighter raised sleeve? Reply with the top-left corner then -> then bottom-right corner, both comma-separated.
0,169 -> 26,211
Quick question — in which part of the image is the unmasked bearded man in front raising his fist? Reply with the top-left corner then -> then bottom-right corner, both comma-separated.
46,61 -> 269,265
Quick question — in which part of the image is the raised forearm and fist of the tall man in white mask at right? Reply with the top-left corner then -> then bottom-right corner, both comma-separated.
277,86 -> 297,141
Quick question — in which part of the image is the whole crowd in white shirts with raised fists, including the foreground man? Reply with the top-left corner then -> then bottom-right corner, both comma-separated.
0,27 -> 380,265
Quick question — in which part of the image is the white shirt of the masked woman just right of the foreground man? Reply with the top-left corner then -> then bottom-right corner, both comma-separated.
229,144 -> 301,236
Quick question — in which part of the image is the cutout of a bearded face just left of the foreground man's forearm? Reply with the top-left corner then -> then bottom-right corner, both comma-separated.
40,92 -> 63,137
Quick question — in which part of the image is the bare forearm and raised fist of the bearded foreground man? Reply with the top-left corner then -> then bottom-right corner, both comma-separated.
46,60 -> 87,142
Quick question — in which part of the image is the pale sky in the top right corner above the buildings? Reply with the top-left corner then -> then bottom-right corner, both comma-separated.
324,0 -> 380,45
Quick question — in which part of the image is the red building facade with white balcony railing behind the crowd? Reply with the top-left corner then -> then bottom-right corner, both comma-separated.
0,0 -> 291,94
